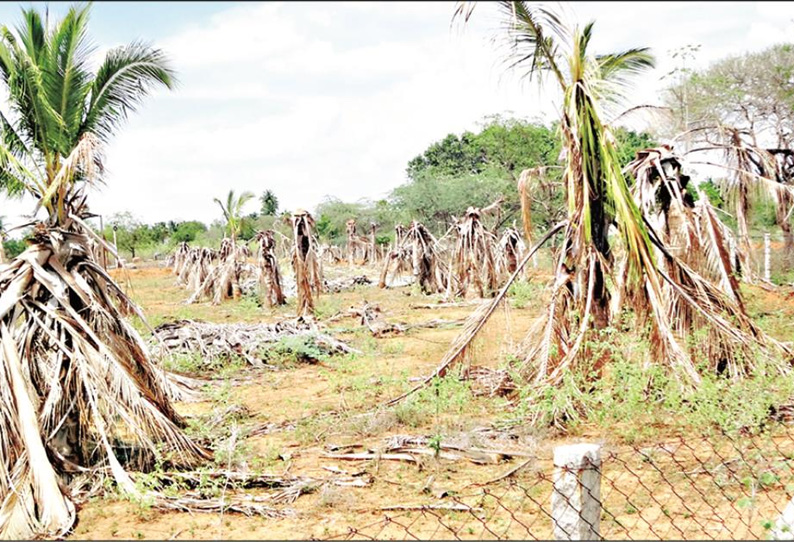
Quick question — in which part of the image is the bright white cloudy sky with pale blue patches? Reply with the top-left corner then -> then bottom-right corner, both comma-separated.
0,2 -> 794,234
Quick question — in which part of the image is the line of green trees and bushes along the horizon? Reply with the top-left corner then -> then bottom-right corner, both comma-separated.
6,39 -> 794,264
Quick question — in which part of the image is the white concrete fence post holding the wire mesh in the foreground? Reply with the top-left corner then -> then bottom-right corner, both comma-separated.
551,444 -> 601,540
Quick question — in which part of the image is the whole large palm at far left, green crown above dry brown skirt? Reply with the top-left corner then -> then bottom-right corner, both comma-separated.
0,6 -> 206,538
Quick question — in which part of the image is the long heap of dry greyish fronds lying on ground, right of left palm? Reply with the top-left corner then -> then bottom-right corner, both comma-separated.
152,318 -> 357,367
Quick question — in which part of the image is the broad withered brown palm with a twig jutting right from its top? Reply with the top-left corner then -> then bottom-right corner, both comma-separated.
447,202 -> 499,297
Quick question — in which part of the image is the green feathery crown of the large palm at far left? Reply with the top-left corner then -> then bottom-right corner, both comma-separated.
0,5 -> 175,224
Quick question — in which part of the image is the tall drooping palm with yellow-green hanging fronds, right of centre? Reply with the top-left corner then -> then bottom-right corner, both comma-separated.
441,1 -> 789,424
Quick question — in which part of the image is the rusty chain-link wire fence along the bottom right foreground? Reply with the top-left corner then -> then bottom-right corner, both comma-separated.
318,424 -> 794,540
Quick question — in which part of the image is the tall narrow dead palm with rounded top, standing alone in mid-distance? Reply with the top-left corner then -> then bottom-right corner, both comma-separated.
292,210 -> 322,317
